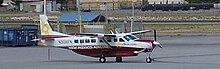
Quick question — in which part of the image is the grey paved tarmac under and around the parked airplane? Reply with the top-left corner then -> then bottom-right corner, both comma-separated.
0,36 -> 220,69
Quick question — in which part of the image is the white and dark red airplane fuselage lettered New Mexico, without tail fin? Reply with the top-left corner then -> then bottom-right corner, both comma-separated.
44,35 -> 154,57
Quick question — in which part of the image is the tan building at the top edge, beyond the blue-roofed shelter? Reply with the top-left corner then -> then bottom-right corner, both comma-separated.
80,0 -> 142,10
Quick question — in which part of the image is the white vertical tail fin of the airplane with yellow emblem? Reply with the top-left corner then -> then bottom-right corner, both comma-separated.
40,15 -> 70,39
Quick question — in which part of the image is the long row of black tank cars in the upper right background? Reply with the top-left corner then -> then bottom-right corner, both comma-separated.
141,3 -> 214,11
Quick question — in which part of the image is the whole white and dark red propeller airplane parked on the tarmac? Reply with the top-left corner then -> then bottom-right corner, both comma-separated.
40,15 -> 161,63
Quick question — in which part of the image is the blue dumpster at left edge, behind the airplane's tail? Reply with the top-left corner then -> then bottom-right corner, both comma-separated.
0,26 -> 38,46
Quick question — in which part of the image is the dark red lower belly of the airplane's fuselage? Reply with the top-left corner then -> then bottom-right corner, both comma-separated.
60,46 -> 148,57
